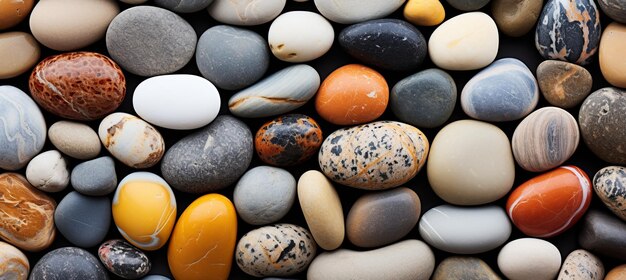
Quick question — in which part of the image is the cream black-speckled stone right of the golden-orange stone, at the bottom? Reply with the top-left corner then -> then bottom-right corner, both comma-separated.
235,224 -> 317,277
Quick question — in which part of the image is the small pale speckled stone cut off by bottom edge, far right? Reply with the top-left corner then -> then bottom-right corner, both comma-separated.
557,249 -> 604,280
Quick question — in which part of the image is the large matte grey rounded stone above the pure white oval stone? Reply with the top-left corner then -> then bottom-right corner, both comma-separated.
106,6 -> 198,76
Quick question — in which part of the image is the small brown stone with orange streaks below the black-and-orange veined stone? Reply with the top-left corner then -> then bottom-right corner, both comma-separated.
537,60 -> 593,109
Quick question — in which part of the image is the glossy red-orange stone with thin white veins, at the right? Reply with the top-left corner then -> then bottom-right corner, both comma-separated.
506,166 -> 593,237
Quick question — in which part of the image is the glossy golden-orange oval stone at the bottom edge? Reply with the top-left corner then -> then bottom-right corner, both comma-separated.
167,194 -> 237,280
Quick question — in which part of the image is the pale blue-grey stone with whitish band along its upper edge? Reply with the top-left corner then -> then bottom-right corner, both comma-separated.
461,58 -> 539,122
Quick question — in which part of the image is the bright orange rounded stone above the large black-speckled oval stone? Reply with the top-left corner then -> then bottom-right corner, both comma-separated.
315,64 -> 389,125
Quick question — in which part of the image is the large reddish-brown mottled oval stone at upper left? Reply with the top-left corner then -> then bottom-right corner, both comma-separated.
28,52 -> 126,120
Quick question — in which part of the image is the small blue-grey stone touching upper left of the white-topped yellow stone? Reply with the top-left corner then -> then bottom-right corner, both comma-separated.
71,156 -> 117,196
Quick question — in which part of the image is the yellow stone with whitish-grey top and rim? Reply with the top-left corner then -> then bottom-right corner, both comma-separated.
111,172 -> 176,251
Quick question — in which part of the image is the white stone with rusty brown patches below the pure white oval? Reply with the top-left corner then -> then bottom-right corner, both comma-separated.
98,112 -> 165,168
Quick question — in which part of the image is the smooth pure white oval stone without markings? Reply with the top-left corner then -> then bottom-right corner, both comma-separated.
133,74 -> 220,129
